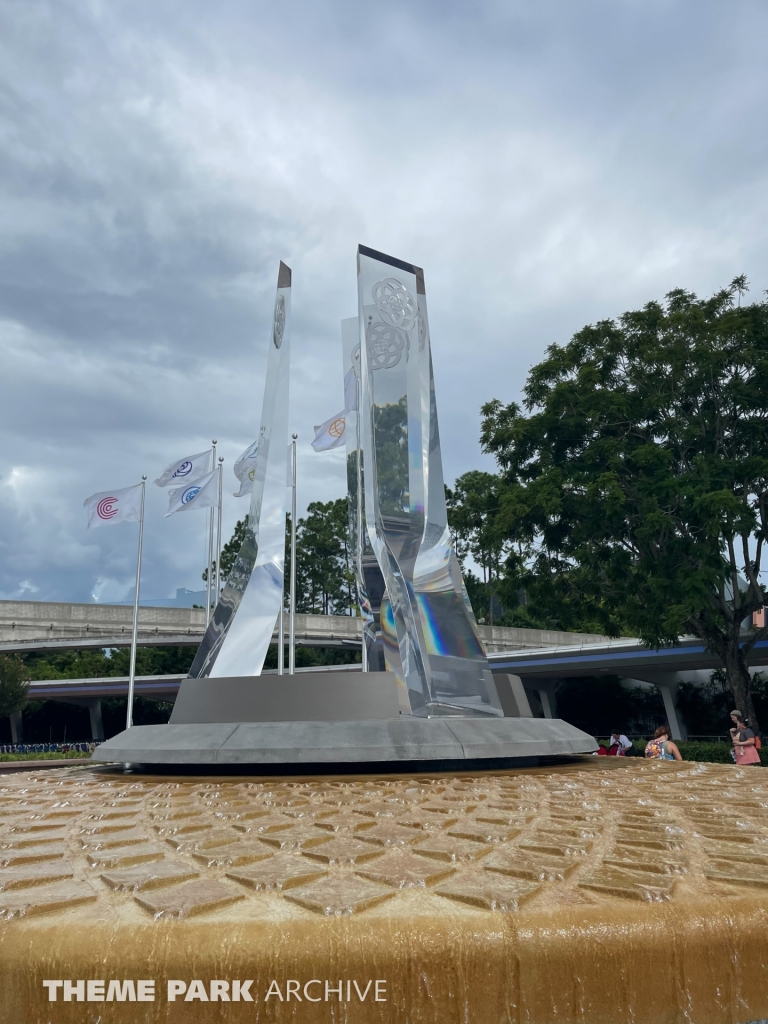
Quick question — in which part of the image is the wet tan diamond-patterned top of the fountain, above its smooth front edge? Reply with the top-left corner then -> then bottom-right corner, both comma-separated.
0,759 -> 768,928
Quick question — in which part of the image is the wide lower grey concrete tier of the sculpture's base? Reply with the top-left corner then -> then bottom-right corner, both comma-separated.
88,715 -> 597,770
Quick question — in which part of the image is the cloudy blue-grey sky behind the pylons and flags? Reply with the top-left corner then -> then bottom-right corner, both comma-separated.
0,0 -> 768,601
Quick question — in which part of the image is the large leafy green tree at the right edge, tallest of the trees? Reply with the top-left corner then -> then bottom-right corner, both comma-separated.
482,279 -> 768,724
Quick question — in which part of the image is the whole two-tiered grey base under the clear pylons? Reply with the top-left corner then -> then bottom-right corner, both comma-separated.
93,672 -> 597,773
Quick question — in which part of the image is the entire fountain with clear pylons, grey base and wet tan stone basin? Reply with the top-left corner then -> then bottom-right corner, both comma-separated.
0,248 -> 768,1024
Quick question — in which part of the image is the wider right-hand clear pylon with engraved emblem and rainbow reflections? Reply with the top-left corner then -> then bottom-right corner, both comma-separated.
356,246 -> 502,716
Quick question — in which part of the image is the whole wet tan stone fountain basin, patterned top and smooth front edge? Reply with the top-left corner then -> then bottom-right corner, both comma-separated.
0,759 -> 768,1024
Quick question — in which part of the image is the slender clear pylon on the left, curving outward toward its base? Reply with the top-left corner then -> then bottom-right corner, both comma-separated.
189,263 -> 291,679
